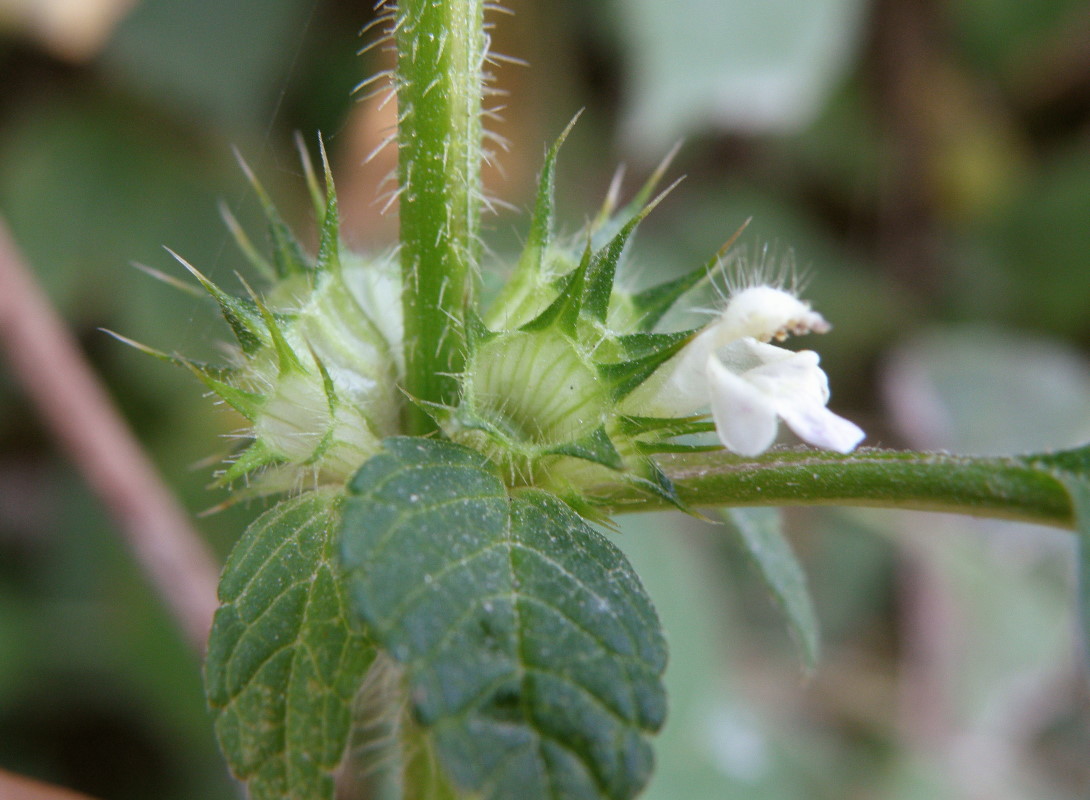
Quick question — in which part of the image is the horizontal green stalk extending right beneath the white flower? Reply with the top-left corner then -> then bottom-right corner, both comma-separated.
590,449 -> 1075,529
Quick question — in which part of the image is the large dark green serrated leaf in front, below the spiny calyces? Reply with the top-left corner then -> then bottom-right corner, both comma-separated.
342,438 -> 666,800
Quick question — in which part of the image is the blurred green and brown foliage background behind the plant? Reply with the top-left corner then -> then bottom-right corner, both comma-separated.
0,0 -> 1090,800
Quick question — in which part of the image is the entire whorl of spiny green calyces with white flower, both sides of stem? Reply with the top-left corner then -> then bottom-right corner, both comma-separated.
126,126 -> 862,516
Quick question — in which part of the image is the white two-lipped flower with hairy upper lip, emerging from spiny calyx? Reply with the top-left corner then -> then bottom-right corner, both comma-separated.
634,286 -> 864,456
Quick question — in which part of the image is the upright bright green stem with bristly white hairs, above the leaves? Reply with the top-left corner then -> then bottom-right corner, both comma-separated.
395,0 -> 486,433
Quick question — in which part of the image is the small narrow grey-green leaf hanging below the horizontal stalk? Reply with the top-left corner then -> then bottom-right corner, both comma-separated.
723,508 -> 821,670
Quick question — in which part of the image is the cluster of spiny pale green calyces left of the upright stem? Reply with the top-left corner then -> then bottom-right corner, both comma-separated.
119,143 -> 404,494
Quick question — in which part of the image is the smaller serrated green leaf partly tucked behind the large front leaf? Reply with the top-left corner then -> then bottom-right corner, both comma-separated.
205,492 -> 375,800
